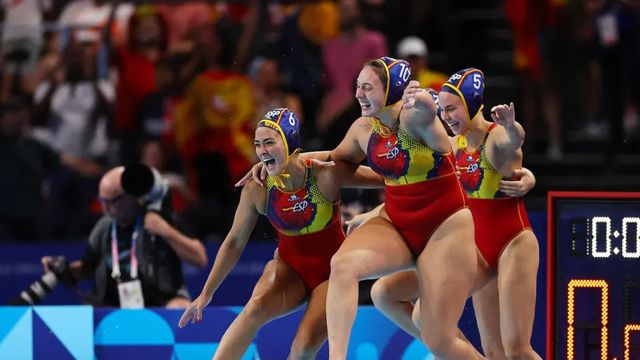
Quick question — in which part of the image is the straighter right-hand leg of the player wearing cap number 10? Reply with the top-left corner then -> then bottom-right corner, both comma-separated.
416,209 -> 478,359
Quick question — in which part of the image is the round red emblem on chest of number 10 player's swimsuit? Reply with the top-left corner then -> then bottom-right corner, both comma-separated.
367,132 -> 411,178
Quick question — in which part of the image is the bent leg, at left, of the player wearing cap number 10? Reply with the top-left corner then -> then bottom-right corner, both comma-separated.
327,217 -> 414,360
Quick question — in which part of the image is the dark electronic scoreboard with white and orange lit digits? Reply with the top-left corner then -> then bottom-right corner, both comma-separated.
547,192 -> 640,360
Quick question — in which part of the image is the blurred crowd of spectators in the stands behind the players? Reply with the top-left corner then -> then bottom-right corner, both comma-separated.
0,0 -> 640,241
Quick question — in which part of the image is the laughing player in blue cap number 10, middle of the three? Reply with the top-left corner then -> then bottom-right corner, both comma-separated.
327,57 -> 477,359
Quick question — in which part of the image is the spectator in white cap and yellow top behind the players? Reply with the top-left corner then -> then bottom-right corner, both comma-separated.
397,36 -> 449,91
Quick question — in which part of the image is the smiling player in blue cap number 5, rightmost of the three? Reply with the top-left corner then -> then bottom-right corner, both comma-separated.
372,68 -> 540,359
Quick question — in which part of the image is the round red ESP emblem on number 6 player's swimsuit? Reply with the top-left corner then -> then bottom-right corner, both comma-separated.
267,187 -> 318,231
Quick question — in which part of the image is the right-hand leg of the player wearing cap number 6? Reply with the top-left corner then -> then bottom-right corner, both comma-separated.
289,281 -> 329,360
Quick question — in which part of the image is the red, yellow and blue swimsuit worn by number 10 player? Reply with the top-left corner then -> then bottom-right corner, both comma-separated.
367,119 -> 467,257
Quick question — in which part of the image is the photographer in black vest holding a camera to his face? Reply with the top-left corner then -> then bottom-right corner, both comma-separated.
42,165 -> 208,308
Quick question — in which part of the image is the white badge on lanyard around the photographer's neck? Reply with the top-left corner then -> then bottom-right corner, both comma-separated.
111,218 -> 144,309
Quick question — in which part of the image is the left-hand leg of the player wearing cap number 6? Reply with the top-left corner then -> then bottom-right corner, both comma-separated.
213,259 -> 307,360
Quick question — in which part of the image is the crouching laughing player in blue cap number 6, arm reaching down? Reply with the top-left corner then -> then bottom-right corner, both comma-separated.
178,108 -> 382,360
